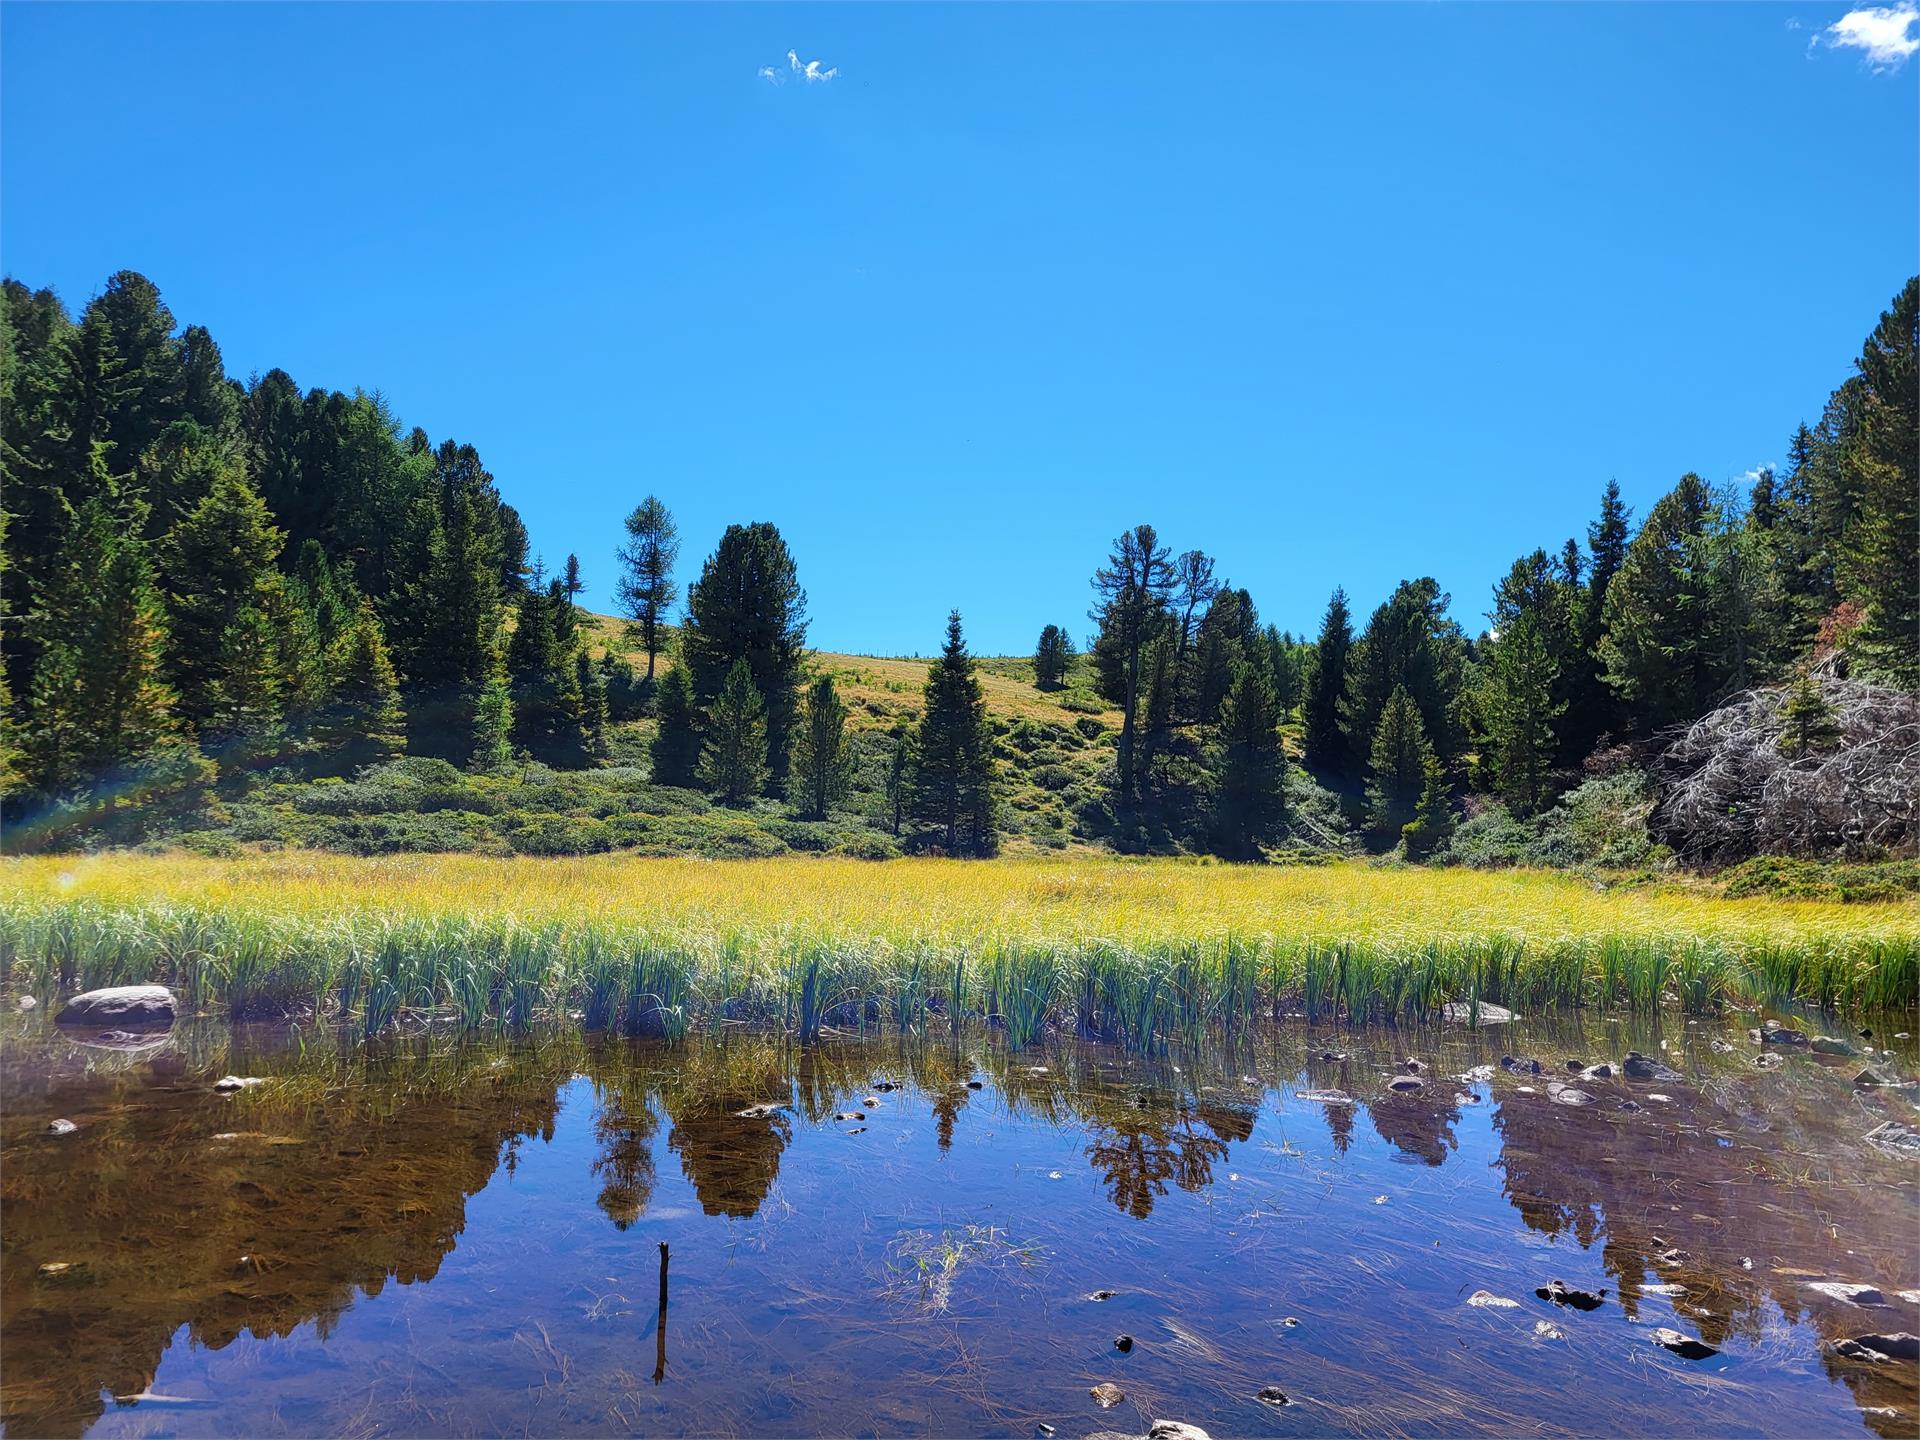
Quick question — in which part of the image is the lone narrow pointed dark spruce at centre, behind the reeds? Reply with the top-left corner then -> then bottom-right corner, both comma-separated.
914,611 -> 998,854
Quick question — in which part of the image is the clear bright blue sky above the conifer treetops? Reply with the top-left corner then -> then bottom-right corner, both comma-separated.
0,4 -> 1920,653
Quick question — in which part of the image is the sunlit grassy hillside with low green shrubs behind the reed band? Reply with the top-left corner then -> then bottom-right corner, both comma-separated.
148,612 -> 1119,858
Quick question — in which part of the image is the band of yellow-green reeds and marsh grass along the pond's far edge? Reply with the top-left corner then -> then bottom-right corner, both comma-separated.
0,854 -> 1920,1050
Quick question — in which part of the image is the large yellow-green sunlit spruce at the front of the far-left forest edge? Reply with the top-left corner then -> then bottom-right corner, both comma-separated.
23,499 -> 175,793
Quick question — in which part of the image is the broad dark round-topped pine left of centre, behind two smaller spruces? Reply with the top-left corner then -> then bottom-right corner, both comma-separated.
682,522 -> 806,793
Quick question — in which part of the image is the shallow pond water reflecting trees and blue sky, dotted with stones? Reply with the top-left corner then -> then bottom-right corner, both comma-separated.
0,1016 -> 1920,1436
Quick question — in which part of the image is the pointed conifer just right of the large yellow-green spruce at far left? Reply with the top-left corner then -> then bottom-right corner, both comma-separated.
161,470 -> 282,733
